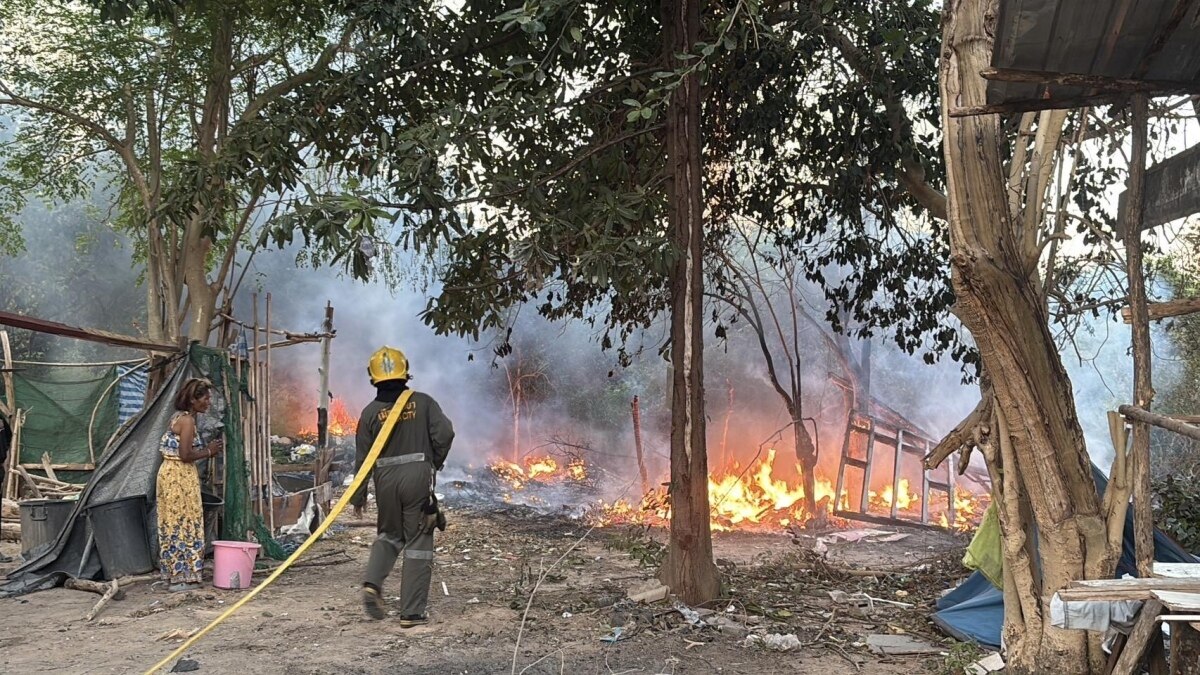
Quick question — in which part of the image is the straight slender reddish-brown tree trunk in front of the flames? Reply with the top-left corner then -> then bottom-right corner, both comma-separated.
661,0 -> 720,604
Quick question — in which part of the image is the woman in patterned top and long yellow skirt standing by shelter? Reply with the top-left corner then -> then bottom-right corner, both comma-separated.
157,378 -> 224,592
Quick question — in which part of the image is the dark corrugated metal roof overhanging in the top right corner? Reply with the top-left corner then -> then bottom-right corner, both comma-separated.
988,0 -> 1200,108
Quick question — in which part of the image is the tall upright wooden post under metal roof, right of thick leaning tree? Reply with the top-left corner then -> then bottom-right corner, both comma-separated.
1123,94 -> 1154,577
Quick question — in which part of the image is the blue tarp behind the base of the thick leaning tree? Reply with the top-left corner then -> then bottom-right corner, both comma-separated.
934,465 -> 1196,649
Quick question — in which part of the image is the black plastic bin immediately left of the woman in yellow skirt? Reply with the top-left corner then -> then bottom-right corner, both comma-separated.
88,495 -> 155,579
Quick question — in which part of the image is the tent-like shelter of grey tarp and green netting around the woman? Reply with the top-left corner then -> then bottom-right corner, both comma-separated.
0,345 -> 284,597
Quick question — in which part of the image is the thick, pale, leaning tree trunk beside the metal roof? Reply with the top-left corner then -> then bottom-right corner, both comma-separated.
940,0 -> 1114,673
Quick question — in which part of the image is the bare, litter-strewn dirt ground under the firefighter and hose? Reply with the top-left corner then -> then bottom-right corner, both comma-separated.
0,508 -> 966,675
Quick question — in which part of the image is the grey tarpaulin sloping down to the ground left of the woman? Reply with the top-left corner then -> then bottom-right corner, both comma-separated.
0,359 -> 194,597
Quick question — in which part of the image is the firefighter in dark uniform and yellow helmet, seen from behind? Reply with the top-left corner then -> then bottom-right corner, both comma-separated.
350,346 -> 454,628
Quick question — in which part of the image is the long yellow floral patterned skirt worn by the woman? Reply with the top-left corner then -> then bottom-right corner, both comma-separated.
157,458 -> 204,584
